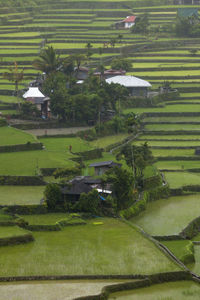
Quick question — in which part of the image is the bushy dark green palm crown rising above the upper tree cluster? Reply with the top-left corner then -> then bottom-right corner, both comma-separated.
33,46 -> 61,75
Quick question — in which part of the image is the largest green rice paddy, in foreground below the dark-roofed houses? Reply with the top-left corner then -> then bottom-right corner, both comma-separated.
0,219 -> 180,276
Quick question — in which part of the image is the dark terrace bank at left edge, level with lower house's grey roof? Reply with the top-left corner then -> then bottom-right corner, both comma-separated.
0,176 -> 46,186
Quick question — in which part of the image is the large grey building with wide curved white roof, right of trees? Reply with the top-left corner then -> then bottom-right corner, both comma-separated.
106,75 -> 151,97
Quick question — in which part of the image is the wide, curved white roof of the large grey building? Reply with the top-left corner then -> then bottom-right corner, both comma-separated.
106,75 -> 151,87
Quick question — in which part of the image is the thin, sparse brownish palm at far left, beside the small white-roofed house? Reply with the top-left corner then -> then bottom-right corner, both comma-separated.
3,62 -> 24,96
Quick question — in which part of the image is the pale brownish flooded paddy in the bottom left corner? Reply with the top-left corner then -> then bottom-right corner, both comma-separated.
0,280 -> 128,300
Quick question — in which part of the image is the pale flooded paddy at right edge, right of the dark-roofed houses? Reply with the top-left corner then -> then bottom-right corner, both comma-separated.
131,194 -> 200,235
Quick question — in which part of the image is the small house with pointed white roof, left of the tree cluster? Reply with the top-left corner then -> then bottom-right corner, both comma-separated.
23,87 -> 50,118
